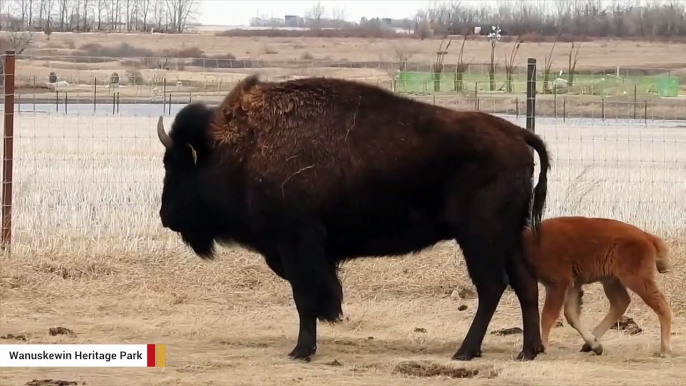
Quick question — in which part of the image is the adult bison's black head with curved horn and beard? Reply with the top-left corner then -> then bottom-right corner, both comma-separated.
157,104 -> 217,258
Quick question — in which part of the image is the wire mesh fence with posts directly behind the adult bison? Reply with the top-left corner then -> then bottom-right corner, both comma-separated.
2,51 -> 686,255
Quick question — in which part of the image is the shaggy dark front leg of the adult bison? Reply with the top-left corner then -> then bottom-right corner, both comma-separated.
281,226 -> 343,361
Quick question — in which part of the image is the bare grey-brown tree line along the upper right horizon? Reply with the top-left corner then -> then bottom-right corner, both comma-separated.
416,0 -> 686,38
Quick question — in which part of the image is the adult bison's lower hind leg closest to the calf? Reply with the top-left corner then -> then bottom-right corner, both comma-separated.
507,252 -> 543,360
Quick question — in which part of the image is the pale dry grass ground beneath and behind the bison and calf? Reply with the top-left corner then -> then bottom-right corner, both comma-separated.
0,111 -> 686,386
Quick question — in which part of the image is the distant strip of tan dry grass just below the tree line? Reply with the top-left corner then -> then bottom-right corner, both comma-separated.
25,33 -> 686,71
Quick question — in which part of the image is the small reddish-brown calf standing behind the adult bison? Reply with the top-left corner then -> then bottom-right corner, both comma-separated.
524,217 -> 672,356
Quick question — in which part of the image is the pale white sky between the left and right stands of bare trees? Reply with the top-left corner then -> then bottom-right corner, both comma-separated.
197,0 -> 436,26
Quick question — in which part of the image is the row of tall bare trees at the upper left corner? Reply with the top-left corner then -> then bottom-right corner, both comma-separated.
0,0 -> 199,33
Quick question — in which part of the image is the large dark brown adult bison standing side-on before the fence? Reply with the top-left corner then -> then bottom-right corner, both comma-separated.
157,75 -> 549,360
